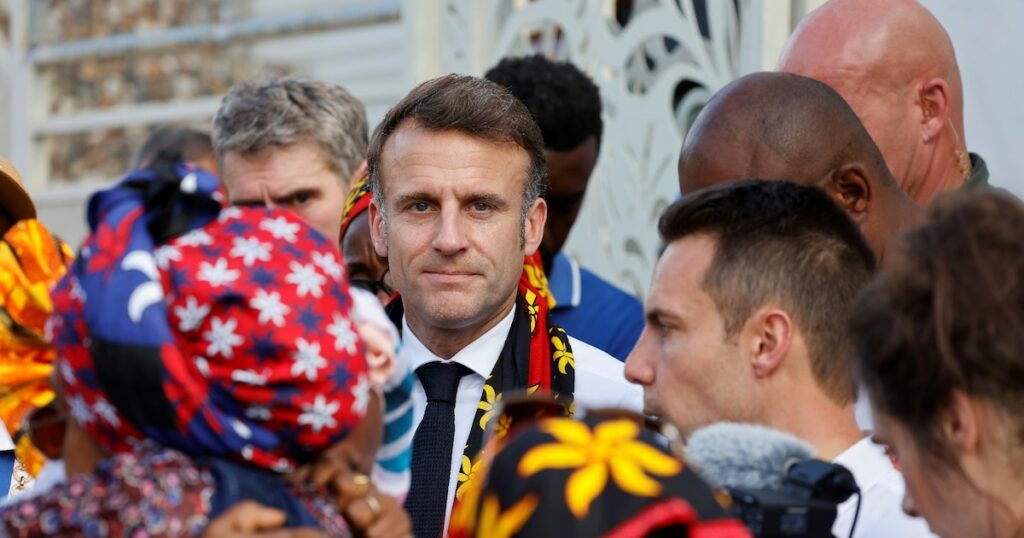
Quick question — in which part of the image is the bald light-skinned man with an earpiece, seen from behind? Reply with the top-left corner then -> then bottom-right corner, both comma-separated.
778,0 -> 988,206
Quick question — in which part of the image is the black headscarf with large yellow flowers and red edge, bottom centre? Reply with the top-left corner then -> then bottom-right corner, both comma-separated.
450,417 -> 751,538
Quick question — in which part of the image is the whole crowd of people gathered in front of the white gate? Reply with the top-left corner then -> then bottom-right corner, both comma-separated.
0,0 -> 1024,538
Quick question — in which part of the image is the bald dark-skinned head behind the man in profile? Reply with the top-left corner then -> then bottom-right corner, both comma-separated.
679,73 -> 923,262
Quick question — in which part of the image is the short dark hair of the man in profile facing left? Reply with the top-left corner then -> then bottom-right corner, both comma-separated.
658,179 -> 874,405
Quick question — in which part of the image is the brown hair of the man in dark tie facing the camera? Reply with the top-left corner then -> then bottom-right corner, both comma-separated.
367,75 -> 547,215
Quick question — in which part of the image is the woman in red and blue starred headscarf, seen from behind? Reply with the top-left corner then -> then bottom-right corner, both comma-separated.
0,158 -> 408,536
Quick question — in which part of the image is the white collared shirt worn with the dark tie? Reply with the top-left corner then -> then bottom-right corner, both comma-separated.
401,307 -> 643,533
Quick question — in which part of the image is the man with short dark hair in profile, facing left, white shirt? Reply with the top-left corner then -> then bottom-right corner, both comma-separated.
626,180 -> 925,536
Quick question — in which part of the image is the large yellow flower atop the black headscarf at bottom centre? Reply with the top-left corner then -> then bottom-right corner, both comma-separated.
520,419 -> 683,518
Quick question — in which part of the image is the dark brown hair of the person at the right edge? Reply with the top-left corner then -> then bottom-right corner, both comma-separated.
852,192 -> 1024,463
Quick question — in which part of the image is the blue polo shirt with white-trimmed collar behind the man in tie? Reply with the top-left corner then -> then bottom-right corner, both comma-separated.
548,252 -> 643,361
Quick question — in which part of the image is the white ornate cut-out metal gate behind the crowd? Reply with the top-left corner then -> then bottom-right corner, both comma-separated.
430,0 -> 790,297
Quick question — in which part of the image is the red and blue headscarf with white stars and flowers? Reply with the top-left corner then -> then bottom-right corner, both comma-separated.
49,163 -> 370,471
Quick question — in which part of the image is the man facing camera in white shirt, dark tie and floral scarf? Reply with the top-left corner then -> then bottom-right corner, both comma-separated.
368,75 -> 640,536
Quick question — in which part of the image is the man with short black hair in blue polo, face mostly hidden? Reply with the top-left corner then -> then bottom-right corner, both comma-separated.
484,54 -> 643,361
